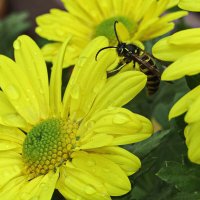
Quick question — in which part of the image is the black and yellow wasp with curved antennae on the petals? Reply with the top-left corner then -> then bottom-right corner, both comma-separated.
95,21 -> 161,95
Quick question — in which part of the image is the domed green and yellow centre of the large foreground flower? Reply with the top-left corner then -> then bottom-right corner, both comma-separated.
22,119 -> 78,178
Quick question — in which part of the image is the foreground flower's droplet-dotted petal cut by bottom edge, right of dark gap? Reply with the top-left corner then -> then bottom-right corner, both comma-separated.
57,166 -> 111,200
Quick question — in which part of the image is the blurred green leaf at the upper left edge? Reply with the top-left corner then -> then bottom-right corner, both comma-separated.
0,12 -> 30,57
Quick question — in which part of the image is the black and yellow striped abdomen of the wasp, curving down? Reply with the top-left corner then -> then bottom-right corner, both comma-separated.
137,54 -> 160,95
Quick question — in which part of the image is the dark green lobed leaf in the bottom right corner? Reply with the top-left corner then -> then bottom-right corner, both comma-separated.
157,161 -> 200,192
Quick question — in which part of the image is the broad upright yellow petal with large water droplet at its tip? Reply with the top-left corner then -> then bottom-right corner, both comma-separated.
13,35 -> 49,119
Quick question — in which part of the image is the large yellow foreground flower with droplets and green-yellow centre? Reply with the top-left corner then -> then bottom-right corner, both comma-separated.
0,36 -> 153,200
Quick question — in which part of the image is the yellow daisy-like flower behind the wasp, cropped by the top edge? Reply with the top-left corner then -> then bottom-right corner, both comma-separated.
36,0 -> 187,66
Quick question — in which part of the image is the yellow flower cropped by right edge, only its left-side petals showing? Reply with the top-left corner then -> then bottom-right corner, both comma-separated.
153,10 -> 200,164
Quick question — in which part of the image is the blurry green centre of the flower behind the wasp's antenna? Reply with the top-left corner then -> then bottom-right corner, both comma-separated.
93,16 -> 137,44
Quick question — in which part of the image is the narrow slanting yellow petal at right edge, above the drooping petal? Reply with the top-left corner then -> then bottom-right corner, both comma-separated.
169,86 -> 200,119
